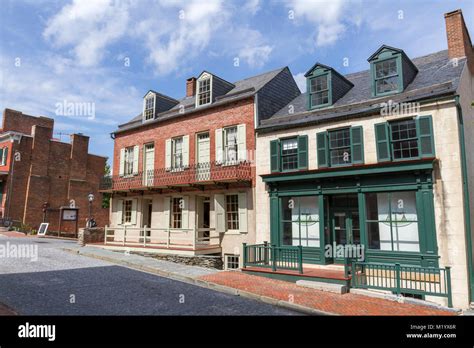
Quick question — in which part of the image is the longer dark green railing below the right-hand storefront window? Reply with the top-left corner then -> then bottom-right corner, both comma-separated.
351,262 -> 453,307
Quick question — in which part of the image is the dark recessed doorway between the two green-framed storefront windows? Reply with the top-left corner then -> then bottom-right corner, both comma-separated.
327,194 -> 360,263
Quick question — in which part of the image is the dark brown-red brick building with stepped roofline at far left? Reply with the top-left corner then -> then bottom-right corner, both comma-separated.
0,110 -> 109,232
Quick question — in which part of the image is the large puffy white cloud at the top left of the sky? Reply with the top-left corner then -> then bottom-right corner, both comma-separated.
43,0 -> 129,66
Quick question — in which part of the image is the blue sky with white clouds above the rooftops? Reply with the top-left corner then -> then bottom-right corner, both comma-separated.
0,0 -> 474,164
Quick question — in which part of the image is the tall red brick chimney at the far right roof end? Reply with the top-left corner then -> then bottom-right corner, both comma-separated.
444,9 -> 474,73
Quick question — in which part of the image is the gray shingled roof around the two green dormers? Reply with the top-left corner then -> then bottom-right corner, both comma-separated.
258,50 -> 465,131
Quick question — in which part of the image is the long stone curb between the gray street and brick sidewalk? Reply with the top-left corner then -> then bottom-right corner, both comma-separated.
62,248 -> 326,316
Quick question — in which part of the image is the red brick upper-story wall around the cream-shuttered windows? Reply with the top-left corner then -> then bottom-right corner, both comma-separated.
113,98 -> 255,185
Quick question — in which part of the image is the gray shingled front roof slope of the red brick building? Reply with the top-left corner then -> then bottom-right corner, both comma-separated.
116,67 -> 286,133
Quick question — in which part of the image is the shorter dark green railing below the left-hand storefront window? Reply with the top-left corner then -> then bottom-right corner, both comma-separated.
243,242 -> 303,273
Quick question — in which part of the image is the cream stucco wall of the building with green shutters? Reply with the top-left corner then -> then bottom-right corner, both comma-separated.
256,95 -> 474,308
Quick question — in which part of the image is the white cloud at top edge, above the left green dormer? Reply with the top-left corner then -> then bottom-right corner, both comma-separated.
287,0 -> 345,46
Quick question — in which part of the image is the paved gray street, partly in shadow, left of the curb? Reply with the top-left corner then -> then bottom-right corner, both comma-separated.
0,236 -> 300,315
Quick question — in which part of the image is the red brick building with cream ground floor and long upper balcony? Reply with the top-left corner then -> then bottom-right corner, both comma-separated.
102,67 -> 300,268
